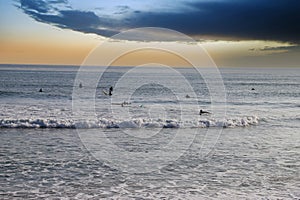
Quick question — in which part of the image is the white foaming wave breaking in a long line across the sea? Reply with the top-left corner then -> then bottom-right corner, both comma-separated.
0,116 -> 259,129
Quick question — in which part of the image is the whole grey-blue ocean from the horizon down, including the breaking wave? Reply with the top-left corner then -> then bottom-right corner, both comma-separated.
0,65 -> 300,199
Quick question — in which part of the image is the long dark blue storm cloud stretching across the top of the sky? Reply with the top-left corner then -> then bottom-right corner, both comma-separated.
20,0 -> 300,44
